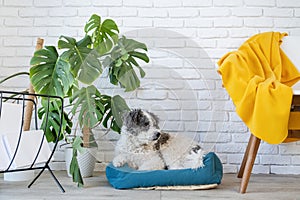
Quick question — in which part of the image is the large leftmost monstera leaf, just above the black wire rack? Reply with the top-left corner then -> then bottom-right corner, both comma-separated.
30,46 -> 74,97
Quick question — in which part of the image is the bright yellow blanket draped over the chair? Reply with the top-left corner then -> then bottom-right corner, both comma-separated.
218,32 -> 300,144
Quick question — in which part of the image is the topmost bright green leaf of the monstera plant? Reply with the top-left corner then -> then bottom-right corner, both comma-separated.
84,14 -> 119,55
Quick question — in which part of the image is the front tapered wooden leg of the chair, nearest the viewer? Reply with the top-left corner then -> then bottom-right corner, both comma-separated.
240,134 -> 260,194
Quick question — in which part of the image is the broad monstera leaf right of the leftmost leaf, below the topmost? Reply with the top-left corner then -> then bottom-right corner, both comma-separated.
58,36 -> 102,84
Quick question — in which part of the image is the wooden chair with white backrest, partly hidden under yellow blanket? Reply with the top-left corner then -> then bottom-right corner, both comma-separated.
238,36 -> 300,193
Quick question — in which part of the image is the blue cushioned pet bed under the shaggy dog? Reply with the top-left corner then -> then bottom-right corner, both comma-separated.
106,152 -> 223,189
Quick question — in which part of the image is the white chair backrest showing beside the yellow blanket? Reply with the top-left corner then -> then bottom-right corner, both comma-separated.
281,36 -> 300,95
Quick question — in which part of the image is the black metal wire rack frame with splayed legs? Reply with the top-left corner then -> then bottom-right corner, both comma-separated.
0,91 -> 65,192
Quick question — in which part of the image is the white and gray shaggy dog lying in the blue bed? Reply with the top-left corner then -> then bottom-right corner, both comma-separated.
113,109 -> 204,170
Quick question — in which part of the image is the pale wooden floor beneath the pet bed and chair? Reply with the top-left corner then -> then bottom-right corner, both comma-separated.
0,171 -> 300,200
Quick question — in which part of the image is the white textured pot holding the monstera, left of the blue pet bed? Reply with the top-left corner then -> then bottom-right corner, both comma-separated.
65,148 -> 97,178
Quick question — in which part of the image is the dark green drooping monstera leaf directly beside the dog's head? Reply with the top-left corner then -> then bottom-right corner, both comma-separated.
101,95 -> 130,133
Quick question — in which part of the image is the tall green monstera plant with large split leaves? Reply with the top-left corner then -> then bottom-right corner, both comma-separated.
30,14 -> 149,188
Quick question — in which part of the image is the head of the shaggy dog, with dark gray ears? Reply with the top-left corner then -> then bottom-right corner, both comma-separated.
122,109 -> 161,144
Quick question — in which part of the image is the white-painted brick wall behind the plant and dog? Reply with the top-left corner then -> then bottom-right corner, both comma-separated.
0,0 -> 300,174
